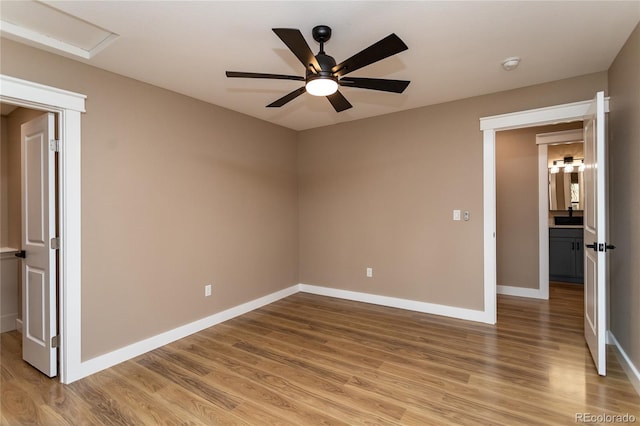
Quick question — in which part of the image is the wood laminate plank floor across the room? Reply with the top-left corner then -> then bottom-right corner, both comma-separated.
0,284 -> 640,425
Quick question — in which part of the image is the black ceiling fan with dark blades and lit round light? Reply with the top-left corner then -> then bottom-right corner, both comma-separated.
226,25 -> 410,112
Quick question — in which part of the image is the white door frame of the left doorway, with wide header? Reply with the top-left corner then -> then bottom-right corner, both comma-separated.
0,74 -> 86,383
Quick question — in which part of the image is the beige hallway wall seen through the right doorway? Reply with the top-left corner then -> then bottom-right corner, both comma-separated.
496,122 -> 582,289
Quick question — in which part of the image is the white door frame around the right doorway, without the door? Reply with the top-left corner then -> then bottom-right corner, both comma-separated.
480,98 -> 609,324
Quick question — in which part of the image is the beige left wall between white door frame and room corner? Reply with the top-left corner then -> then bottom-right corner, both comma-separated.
2,40 -> 298,360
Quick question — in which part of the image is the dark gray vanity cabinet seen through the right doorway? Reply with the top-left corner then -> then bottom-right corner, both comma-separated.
549,228 -> 584,283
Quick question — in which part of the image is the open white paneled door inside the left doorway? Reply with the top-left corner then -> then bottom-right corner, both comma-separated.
22,113 -> 58,377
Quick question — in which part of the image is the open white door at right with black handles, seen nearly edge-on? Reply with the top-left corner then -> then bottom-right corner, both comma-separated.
584,92 -> 615,376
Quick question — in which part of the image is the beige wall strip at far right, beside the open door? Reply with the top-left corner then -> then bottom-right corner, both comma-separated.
609,27 -> 640,369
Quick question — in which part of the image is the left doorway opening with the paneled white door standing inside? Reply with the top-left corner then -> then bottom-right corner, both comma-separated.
0,103 -> 59,377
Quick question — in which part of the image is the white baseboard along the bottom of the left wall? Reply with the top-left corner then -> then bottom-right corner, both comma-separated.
76,285 -> 299,379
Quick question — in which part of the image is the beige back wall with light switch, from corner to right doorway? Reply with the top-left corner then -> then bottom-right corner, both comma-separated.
298,73 -> 607,310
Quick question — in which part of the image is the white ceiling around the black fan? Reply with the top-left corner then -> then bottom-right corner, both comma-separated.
2,0 -> 640,130
